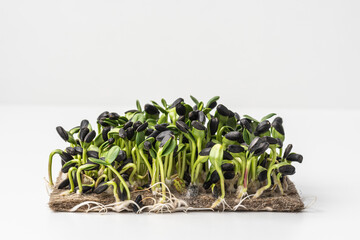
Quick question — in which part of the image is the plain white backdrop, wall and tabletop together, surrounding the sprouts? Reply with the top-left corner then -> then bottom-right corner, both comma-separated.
0,0 -> 360,239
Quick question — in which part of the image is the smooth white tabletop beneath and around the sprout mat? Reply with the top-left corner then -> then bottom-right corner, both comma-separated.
0,105 -> 360,240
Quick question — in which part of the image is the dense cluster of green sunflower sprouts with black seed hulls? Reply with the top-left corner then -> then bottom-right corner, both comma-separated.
48,96 -> 303,212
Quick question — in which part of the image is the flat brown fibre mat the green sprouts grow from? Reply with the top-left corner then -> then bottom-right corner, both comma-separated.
49,173 -> 304,212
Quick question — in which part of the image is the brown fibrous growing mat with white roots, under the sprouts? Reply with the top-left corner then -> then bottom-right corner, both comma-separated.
49,173 -> 304,213
